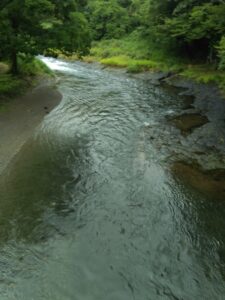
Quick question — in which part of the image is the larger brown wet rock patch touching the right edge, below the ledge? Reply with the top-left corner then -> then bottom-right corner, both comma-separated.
172,162 -> 225,201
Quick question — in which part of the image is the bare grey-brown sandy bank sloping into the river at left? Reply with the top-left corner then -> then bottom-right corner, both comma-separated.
0,79 -> 61,174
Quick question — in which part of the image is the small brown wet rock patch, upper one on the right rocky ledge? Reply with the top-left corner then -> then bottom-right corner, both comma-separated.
171,113 -> 208,134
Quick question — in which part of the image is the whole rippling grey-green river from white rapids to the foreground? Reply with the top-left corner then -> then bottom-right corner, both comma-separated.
0,59 -> 225,300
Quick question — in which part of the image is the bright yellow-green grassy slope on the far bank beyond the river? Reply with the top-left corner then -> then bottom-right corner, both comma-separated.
89,32 -> 183,72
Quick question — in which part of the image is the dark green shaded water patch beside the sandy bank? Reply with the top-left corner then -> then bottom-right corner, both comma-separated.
0,141 -> 75,242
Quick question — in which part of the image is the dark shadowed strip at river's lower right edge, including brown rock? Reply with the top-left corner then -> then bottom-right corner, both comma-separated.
171,161 -> 225,280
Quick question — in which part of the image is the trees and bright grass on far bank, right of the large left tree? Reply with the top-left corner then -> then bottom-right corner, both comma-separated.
81,0 -> 225,89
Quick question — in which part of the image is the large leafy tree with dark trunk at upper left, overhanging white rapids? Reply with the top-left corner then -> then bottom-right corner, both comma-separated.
0,0 -> 90,74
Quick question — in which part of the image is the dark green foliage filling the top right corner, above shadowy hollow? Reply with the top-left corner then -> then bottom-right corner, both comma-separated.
146,0 -> 225,63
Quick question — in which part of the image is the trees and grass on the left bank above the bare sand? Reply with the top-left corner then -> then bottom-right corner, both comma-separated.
0,0 -> 90,97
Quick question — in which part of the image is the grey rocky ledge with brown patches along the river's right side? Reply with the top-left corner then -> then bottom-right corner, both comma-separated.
59,50 -> 225,200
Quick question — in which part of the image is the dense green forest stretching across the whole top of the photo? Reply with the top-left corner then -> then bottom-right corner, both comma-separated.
0,0 -> 225,79
